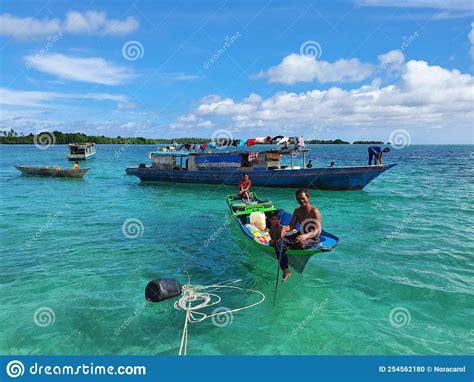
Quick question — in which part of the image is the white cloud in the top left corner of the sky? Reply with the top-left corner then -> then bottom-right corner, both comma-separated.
0,11 -> 139,40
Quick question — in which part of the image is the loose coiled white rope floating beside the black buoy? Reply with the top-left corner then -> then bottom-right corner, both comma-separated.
174,274 -> 265,355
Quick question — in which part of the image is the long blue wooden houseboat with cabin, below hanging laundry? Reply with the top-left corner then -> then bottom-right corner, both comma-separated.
126,149 -> 395,190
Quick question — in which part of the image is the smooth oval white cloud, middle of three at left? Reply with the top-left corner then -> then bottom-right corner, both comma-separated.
25,54 -> 133,85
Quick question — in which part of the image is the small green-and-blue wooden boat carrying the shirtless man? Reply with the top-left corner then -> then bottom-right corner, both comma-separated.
227,192 -> 339,273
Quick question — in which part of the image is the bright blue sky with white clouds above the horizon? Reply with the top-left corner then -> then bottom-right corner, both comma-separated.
0,0 -> 474,143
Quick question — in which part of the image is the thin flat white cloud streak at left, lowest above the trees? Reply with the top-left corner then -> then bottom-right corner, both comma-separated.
0,88 -> 128,107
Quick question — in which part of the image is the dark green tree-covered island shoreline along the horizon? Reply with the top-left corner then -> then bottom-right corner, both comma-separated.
0,129 -> 383,145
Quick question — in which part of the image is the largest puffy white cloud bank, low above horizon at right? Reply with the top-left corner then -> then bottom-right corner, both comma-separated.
170,57 -> 474,135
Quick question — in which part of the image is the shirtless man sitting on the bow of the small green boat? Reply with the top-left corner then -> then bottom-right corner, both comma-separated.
270,188 -> 321,282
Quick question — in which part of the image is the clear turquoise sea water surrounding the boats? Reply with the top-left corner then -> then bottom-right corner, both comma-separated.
0,145 -> 474,355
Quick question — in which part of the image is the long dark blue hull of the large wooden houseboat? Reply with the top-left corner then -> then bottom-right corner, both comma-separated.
126,164 -> 395,190
